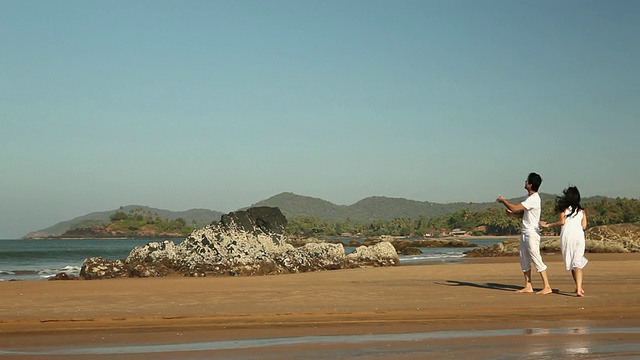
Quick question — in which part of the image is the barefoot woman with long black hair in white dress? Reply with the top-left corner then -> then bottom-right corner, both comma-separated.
540,186 -> 588,297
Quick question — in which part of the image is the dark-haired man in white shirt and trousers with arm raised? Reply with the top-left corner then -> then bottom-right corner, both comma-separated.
496,173 -> 552,295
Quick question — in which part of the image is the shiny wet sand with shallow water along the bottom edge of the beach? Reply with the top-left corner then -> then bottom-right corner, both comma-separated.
0,327 -> 640,359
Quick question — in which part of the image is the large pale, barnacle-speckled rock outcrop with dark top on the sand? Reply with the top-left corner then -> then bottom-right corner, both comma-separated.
80,207 -> 400,279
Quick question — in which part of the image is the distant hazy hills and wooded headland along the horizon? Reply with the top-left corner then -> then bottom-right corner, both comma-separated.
24,192 -> 640,239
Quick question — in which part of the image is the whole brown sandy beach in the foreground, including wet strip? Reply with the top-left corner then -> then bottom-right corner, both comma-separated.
0,254 -> 640,359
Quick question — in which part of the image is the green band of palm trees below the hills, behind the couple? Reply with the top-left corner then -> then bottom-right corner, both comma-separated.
287,198 -> 640,237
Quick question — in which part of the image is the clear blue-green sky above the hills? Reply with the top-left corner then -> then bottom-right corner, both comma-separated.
0,0 -> 640,239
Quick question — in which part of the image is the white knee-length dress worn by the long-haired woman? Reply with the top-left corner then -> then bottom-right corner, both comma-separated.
560,208 -> 589,271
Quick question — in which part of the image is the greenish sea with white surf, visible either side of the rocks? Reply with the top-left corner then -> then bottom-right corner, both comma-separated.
0,238 -> 504,281
